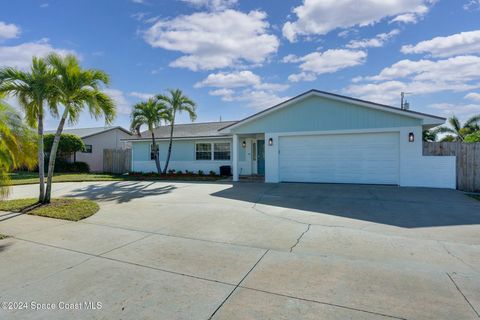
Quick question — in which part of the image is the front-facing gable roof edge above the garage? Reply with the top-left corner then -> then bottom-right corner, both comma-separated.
220,89 -> 446,132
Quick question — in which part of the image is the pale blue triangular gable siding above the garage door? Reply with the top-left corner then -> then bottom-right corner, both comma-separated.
232,97 -> 422,134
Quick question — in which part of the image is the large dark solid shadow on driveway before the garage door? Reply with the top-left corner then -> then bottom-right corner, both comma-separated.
212,182 -> 480,228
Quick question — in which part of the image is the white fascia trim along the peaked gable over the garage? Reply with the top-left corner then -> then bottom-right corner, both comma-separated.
219,91 -> 445,132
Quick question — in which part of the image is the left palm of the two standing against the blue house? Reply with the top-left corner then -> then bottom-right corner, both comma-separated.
130,98 -> 169,174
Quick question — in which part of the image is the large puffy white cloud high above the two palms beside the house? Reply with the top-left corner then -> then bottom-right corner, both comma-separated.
144,9 -> 279,71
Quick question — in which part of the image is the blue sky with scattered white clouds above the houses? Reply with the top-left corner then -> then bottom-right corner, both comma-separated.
0,0 -> 480,129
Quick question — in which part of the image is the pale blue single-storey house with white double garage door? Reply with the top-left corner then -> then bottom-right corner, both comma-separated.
127,90 -> 456,188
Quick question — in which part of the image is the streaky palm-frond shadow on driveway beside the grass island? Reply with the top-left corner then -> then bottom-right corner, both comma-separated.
65,181 -> 177,203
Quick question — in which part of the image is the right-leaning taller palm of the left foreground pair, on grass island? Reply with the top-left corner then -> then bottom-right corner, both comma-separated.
44,53 -> 115,203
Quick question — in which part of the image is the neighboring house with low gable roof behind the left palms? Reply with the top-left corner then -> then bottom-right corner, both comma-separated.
45,127 -> 132,172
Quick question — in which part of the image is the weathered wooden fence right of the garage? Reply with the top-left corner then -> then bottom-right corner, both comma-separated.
423,142 -> 480,192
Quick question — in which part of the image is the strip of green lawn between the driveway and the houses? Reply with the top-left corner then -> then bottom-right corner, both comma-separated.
10,172 -> 221,185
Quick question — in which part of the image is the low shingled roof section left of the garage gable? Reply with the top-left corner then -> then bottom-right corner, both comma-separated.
127,121 -> 237,140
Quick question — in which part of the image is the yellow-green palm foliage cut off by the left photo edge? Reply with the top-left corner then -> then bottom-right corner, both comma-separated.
0,97 -> 37,199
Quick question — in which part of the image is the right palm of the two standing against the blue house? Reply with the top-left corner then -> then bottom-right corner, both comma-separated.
156,89 -> 197,174
